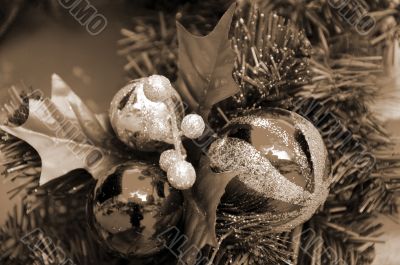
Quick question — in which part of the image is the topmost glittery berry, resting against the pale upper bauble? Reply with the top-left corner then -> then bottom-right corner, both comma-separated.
143,75 -> 172,102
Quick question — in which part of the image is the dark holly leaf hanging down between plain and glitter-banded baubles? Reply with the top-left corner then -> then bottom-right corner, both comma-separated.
181,157 -> 240,264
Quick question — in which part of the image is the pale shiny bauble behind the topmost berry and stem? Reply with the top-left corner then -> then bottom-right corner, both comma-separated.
109,78 -> 184,151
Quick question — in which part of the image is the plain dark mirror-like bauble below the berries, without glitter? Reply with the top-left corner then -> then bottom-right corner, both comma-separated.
88,162 -> 183,257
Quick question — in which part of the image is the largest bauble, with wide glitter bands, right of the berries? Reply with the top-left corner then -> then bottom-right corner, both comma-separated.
208,109 -> 330,232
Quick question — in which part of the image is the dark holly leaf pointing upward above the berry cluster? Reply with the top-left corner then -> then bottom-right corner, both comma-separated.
177,4 -> 239,120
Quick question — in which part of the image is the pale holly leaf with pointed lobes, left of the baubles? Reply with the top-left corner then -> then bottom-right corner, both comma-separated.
0,74 -> 129,185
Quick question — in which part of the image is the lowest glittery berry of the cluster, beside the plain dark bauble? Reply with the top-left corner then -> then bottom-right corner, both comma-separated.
167,160 -> 196,190
